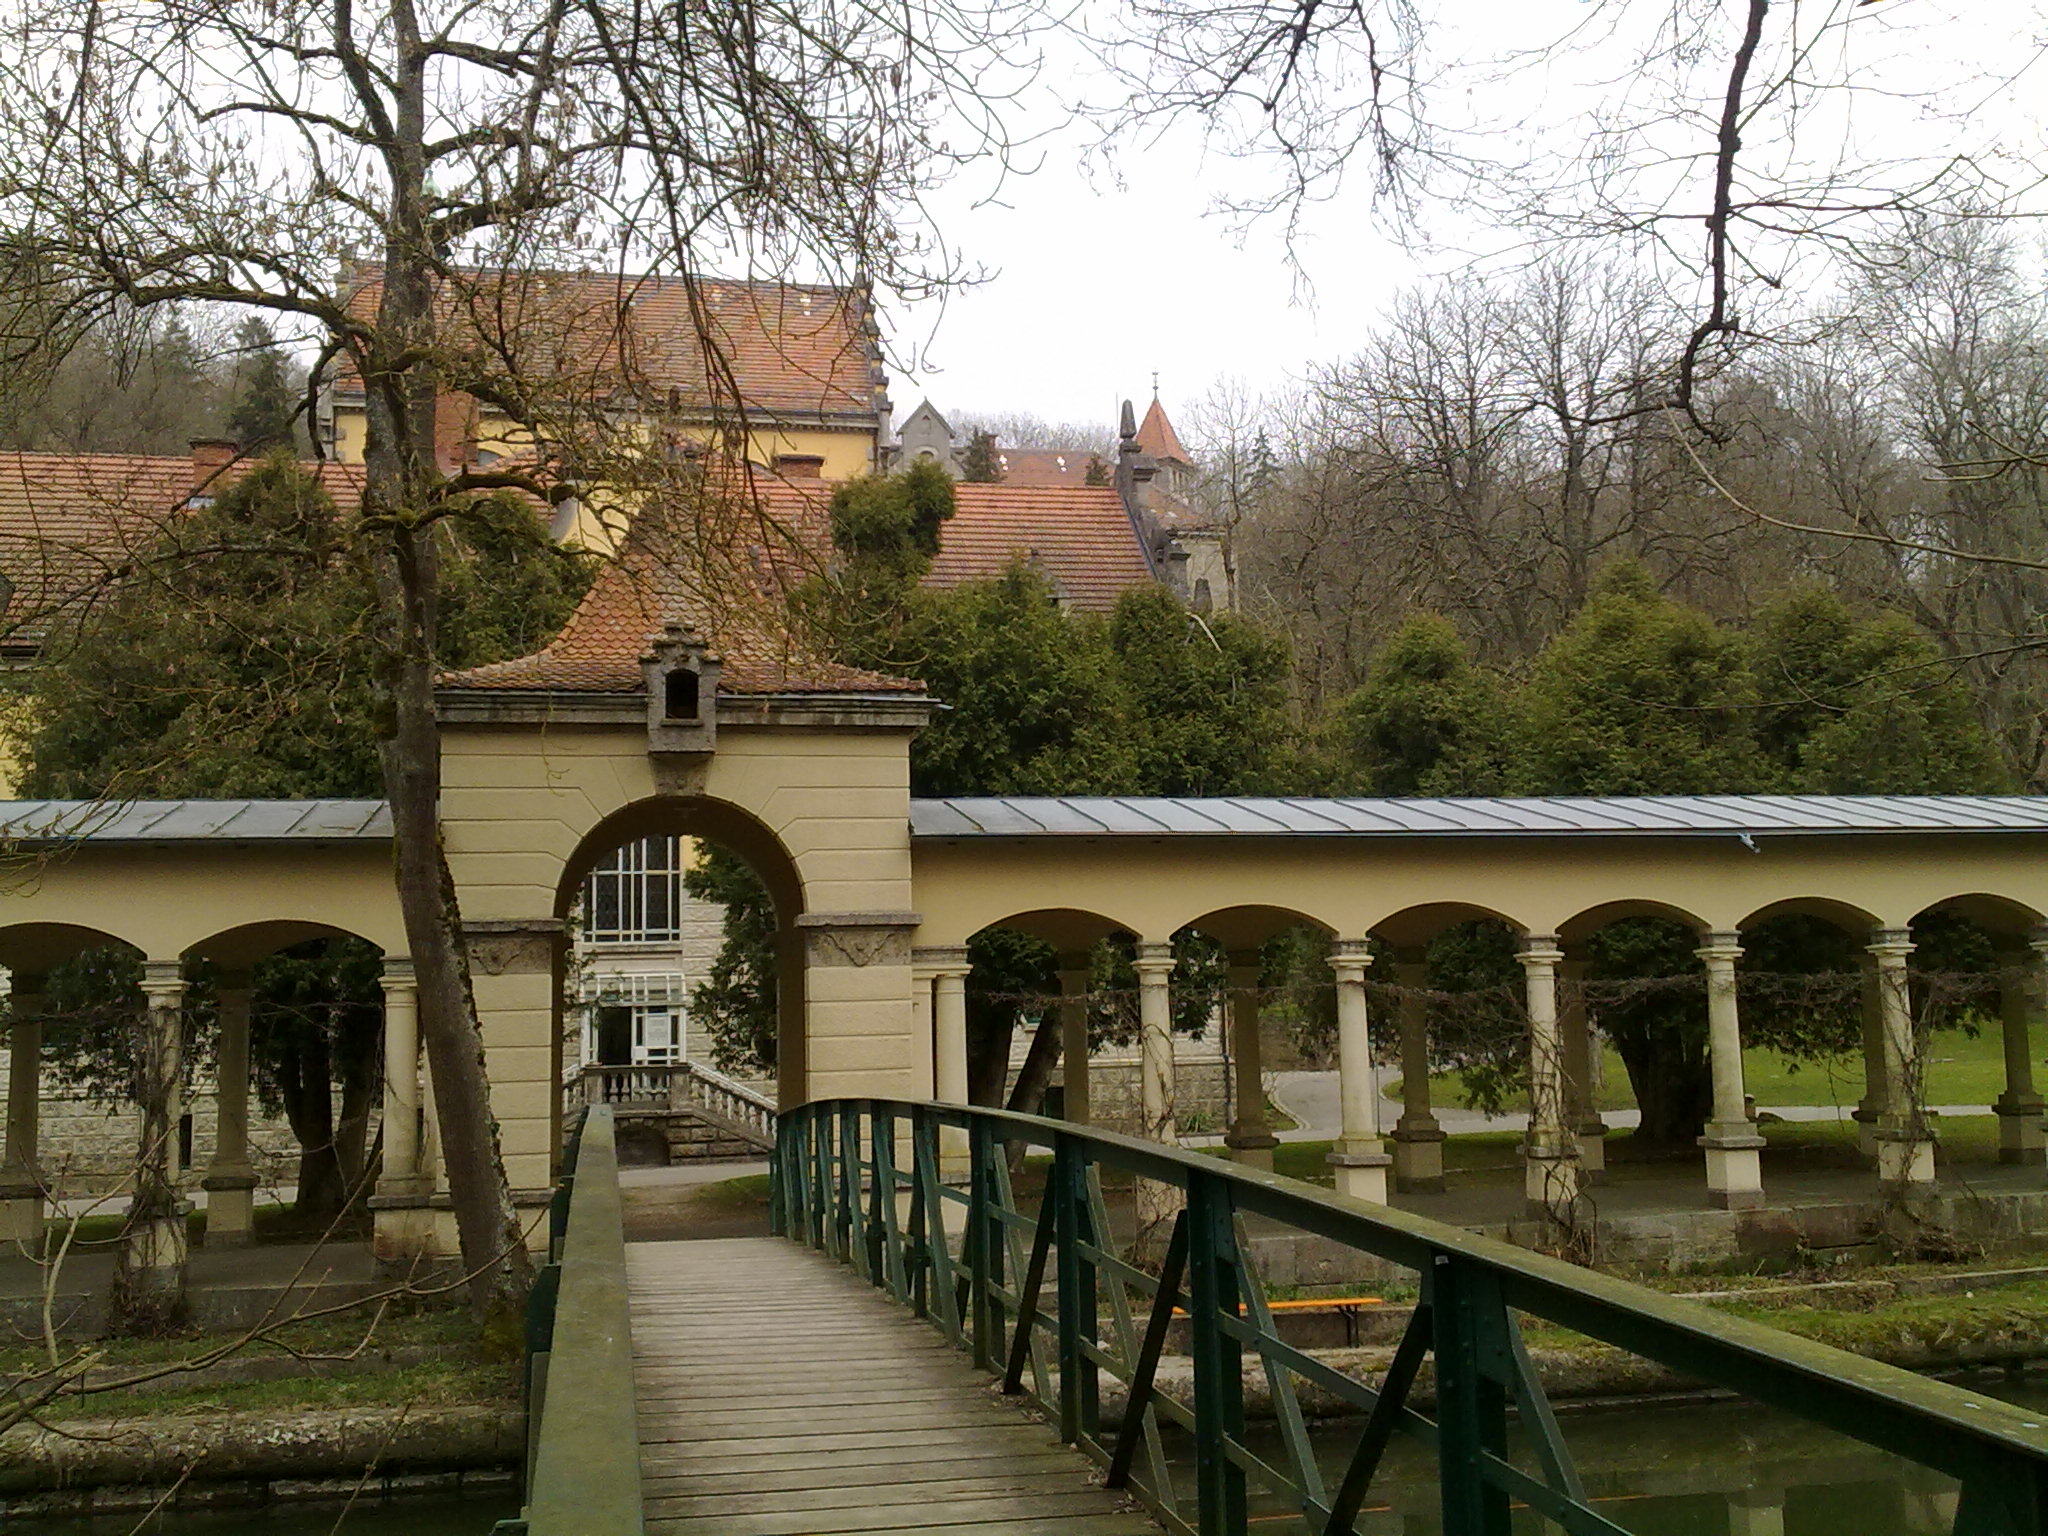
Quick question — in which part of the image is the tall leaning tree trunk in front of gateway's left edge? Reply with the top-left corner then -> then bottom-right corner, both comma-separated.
362,195 -> 532,1317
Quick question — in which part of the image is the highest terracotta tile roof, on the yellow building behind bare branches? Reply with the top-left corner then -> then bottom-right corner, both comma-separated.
336,266 -> 883,420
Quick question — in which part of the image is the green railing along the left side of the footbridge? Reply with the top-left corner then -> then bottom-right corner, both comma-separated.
498,1104 -> 645,1536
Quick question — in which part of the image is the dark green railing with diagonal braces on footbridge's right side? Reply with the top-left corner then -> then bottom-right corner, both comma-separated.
772,1100 -> 2048,1536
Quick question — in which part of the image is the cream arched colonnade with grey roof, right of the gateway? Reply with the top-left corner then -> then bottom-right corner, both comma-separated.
913,799 -> 2048,1210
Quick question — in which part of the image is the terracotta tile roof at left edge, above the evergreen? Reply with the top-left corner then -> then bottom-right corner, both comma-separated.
0,453 -> 362,649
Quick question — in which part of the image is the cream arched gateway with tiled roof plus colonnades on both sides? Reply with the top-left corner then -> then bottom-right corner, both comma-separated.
0,567 -> 2048,1260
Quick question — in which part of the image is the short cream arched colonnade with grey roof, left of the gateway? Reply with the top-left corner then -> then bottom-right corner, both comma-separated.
0,801 -> 415,1290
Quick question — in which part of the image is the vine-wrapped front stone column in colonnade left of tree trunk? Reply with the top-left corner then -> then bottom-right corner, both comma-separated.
111,961 -> 190,1327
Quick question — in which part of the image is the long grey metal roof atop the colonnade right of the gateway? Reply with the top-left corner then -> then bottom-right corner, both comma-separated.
911,795 -> 2048,838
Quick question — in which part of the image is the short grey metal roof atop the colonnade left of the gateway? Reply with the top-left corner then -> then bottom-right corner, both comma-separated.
0,801 -> 391,844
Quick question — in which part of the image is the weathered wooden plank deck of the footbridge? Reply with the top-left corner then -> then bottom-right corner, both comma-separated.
627,1237 -> 1159,1536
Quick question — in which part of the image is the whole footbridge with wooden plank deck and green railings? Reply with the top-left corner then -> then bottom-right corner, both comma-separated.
502,1100 -> 2048,1536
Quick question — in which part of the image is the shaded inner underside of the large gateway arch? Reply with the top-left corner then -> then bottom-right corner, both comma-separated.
553,795 -> 807,1104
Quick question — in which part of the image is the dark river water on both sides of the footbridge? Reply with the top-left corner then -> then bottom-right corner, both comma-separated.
8,1380 -> 2048,1536
